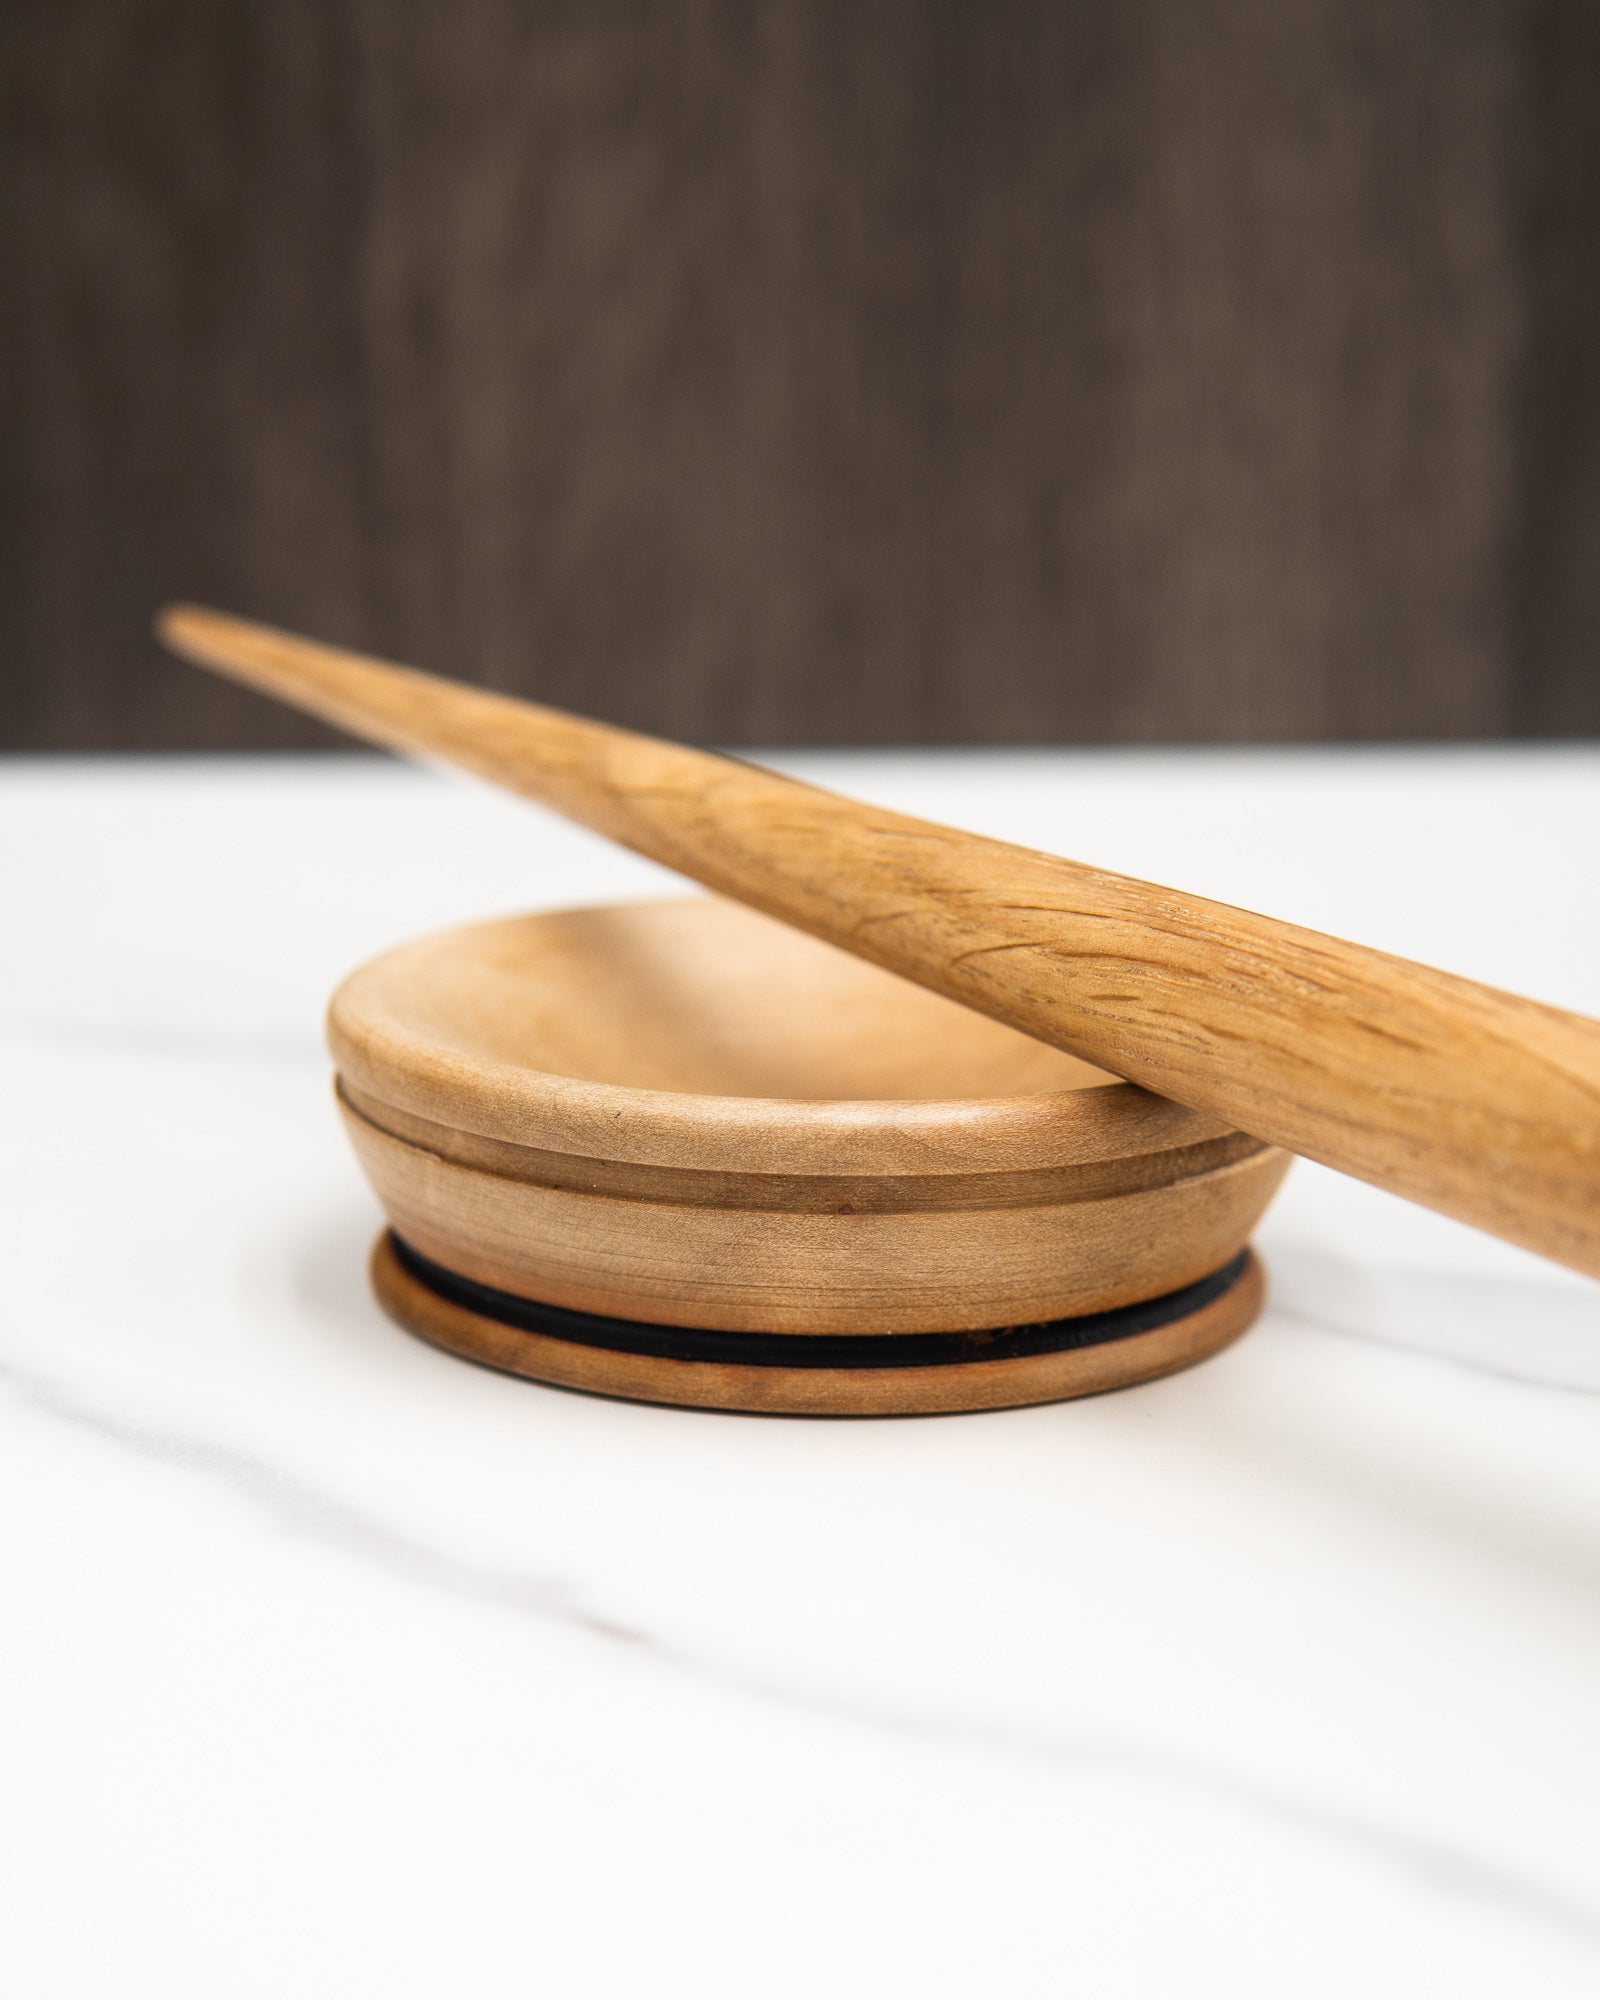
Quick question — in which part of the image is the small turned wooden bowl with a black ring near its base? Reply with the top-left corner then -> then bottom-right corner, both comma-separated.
328,898 -> 1288,1414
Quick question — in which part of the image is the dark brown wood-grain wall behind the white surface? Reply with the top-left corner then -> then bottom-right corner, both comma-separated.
0,0 -> 1600,748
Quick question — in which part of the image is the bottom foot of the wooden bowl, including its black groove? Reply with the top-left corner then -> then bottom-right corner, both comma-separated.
372,1230 -> 1264,1416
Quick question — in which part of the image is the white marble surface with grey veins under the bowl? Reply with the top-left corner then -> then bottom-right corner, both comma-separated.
0,750 -> 1600,2000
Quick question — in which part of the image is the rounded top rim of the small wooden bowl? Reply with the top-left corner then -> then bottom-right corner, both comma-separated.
326,896 -> 1234,1174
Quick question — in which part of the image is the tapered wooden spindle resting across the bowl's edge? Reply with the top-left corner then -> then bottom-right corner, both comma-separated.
160,606 -> 1600,1276
